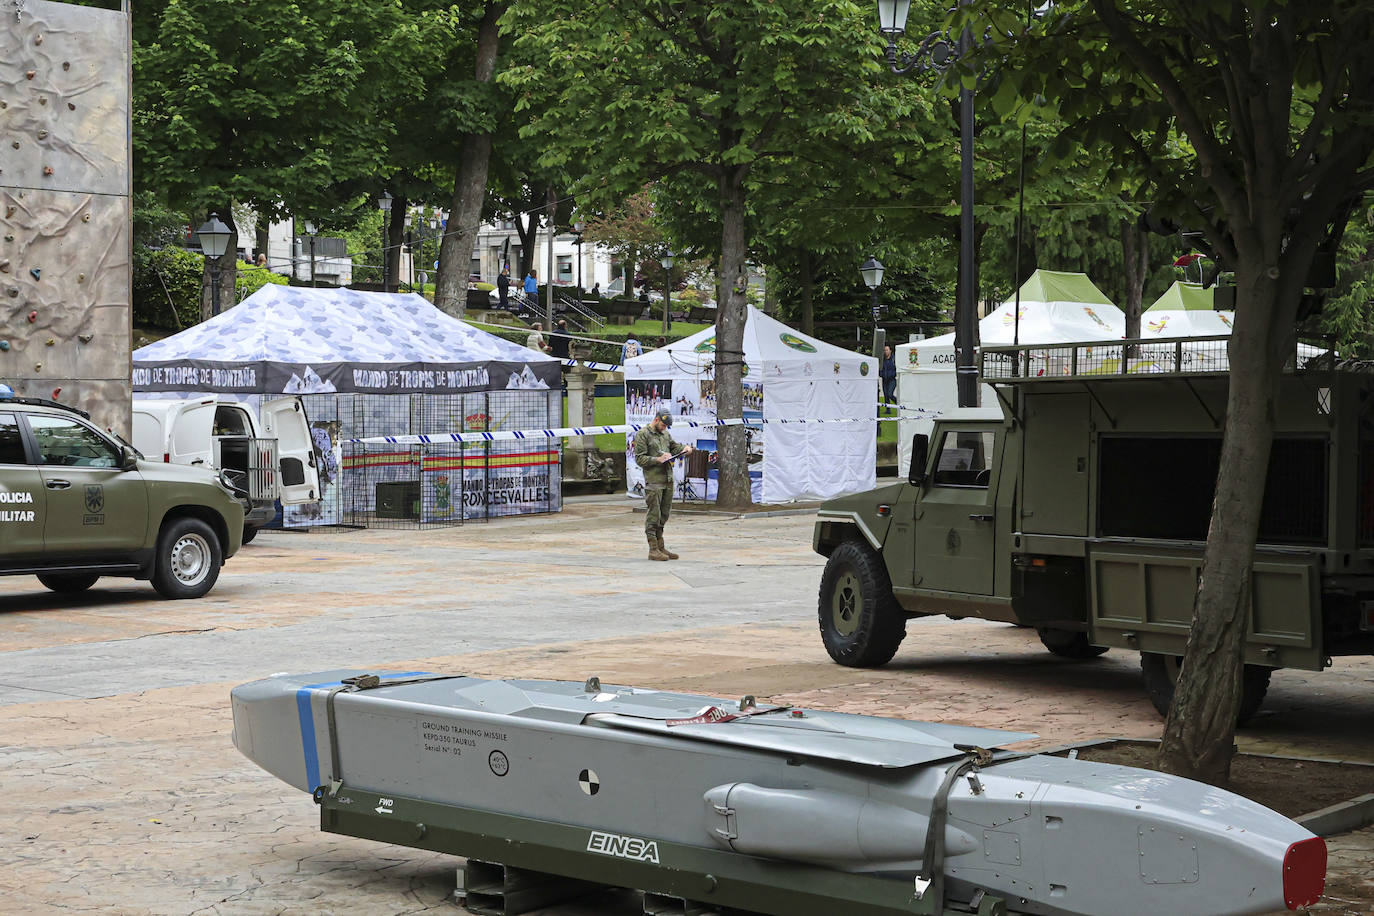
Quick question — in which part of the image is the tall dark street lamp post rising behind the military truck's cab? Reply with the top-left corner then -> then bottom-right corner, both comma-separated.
878,0 -> 978,407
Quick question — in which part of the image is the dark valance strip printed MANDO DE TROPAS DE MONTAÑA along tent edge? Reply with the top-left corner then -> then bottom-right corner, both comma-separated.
133,360 -> 561,394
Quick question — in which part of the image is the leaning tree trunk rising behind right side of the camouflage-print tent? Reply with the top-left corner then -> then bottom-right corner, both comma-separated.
434,0 -> 502,317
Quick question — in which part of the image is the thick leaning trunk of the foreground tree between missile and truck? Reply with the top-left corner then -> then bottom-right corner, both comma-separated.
1157,269 -> 1296,786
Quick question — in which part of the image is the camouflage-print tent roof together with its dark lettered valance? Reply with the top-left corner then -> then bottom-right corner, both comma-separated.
133,284 -> 559,394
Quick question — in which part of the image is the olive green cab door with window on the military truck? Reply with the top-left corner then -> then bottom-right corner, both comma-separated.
912,428 -> 1002,595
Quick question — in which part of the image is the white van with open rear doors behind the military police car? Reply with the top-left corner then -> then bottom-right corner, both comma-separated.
133,396 -> 320,544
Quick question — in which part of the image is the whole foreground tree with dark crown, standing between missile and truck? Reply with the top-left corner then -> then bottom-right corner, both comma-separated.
971,0 -> 1374,781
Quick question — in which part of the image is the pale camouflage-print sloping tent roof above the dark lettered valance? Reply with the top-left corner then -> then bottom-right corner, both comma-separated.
133,284 -> 555,364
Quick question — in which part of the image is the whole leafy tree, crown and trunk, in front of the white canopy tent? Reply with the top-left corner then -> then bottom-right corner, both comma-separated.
503,0 -> 878,505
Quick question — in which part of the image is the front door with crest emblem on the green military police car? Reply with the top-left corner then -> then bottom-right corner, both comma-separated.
26,413 -> 148,555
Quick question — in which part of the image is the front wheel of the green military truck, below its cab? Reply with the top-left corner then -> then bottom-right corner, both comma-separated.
818,541 -> 907,667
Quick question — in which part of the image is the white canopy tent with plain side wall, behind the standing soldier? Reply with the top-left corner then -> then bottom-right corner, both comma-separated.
625,306 -> 878,503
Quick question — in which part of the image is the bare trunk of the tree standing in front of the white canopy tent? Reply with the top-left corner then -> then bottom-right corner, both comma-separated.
716,168 -> 753,508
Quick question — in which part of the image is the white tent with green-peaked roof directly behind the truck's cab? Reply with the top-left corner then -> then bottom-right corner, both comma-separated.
893,271 -> 1125,474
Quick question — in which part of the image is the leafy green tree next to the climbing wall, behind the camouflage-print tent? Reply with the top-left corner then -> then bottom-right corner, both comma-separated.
133,0 -> 394,318
